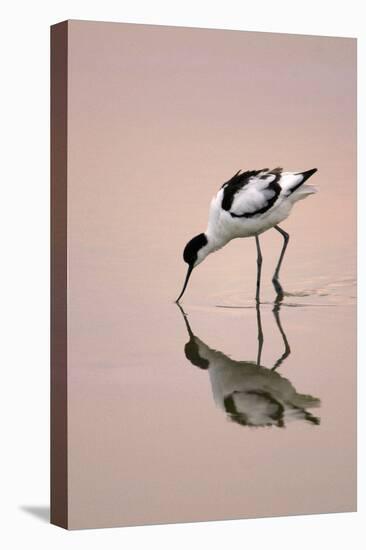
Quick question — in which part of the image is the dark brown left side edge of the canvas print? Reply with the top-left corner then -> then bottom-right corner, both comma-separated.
50,21 -> 68,529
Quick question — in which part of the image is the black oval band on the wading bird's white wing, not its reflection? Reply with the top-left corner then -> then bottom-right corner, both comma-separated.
221,168 -> 282,218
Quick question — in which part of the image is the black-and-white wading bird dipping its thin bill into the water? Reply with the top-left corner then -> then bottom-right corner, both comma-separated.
176,168 -> 317,302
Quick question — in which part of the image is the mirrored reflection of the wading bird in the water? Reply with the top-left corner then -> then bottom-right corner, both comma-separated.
178,303 -> 320,427
